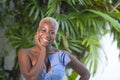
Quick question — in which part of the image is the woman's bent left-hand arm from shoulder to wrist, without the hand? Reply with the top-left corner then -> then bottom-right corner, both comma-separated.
18,49 -> 45,80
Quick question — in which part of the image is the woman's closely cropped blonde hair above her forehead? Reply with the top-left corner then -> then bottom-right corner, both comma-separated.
38,17 -> 59,33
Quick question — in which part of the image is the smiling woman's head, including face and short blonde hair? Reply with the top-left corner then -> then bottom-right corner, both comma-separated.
37,17 -> 58,46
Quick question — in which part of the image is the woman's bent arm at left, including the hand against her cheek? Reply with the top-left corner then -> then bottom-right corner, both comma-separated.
18,34 -> 46,80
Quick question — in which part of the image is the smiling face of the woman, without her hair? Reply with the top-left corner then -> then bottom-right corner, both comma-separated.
38,23 -> 56,46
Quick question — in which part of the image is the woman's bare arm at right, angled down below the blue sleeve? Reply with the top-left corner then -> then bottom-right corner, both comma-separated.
66,52 -> 90,80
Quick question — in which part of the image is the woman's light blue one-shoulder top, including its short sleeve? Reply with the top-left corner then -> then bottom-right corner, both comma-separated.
39,51 -> 70,80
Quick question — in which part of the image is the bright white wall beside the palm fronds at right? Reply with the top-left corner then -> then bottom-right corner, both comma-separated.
91,34 -> 120,80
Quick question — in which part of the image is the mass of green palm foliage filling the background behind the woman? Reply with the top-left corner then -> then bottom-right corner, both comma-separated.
0,0 -> 120,80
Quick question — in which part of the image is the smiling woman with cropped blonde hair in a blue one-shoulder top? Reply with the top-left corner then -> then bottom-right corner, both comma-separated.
18,17 -> 90,80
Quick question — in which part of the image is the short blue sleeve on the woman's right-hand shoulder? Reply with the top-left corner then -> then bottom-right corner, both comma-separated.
60,51 -> 71,66
